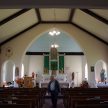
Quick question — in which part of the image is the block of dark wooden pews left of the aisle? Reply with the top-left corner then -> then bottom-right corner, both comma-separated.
0,88 -> 46,108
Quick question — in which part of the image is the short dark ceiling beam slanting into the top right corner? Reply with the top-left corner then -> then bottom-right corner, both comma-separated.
81,9 -> 108,24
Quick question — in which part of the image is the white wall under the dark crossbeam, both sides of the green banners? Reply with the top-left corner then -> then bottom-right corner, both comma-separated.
24,55 -> 83,85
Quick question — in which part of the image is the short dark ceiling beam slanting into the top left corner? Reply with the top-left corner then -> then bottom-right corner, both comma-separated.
0,9 -> 30,26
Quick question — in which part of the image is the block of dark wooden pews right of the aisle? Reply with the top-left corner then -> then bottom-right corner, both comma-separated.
61,88 -> 108,108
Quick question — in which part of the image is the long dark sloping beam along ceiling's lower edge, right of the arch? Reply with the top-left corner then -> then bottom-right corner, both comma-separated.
71,22 -> 108,45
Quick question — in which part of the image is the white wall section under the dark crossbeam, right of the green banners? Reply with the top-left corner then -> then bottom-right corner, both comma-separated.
65,56 -> 83,86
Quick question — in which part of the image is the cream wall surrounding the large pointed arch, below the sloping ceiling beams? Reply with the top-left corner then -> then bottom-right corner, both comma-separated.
1,24 -> 108,81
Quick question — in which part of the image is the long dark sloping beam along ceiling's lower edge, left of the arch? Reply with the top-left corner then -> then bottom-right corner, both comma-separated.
0,23 -> 39,46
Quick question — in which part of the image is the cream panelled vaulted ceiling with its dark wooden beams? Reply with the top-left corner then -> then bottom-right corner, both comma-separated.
0,8 -> 108,45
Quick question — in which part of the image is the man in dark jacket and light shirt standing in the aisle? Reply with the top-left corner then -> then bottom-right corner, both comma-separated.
48,76 -> 60,108
